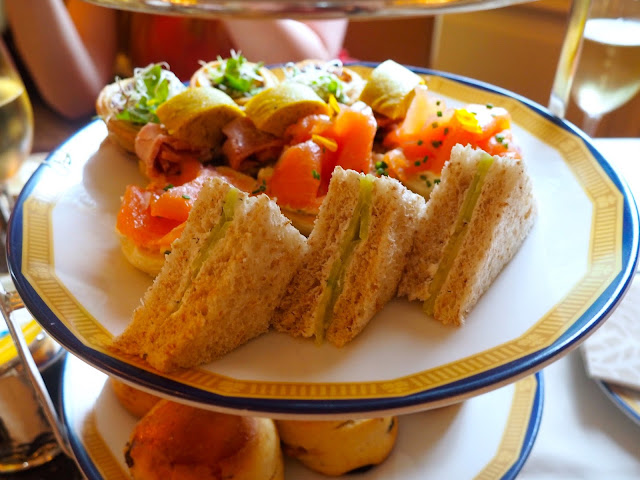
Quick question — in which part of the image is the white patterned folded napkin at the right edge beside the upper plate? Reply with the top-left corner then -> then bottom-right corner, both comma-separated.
581,274 -> 640,390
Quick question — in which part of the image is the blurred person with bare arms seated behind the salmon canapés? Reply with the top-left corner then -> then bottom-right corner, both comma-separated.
0,0 -> 347,119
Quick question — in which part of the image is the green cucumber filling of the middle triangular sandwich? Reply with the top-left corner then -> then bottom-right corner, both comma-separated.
315,175 -> 374,343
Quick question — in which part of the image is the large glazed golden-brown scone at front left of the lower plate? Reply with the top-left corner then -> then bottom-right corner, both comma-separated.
125,400 -> 284,480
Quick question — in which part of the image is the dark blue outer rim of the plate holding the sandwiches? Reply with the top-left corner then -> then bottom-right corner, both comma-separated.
7,62 -> 640,415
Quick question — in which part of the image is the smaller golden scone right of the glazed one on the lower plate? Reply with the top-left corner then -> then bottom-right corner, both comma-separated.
276,417 -> 398,476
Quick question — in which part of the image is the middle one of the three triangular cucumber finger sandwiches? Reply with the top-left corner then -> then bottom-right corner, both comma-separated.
273,167 -> 425,346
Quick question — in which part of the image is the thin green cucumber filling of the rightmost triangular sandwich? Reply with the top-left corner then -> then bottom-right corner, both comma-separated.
423,154 -> 493,315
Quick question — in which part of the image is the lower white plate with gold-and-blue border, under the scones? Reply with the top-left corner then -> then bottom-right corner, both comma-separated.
61,355 -> 543,480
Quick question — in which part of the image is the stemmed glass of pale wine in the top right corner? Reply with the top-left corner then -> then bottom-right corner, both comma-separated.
571,0 -> 640,136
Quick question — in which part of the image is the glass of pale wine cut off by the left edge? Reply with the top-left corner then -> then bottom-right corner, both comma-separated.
0,39 -> 33,208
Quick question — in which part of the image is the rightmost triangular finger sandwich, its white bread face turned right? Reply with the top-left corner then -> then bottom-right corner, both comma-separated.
398,145 -> 537,325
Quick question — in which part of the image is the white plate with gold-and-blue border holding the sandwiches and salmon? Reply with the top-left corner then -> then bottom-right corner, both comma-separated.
8,63 -> 638,417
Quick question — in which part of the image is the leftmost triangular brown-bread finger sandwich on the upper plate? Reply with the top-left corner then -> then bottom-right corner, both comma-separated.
113,178 -> 306,371
